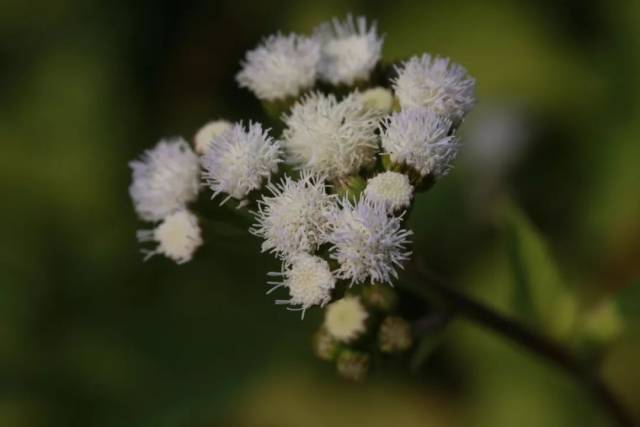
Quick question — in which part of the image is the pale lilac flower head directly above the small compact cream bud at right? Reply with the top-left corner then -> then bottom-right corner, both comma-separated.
381,108 -> 458,178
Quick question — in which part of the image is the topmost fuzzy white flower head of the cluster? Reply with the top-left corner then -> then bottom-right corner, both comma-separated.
315,15 -> 383,85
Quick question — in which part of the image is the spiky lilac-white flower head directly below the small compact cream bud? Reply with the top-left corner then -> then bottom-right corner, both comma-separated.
328,197 -> 413,284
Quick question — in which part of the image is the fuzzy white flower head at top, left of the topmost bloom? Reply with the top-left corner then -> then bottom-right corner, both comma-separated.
236,34 -> 320,101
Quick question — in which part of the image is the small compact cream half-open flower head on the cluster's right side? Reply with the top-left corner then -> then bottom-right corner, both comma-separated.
364,171 -> 413,212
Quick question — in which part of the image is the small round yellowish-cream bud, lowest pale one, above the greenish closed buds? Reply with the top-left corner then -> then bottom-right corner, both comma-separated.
324,296 -> 369,342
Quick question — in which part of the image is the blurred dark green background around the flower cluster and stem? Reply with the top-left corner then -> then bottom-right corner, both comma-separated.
0,0 -> 640,427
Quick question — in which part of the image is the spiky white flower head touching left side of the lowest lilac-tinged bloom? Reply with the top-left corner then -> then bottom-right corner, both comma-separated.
249,173 -> 337,259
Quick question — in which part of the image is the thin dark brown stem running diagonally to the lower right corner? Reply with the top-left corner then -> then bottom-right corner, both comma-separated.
408,269 -> 635,427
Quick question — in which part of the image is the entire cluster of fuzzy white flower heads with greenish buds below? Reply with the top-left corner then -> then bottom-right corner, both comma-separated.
130,16 -> 475,379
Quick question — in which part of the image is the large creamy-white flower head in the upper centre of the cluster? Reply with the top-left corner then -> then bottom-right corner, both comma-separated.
283,93 -> 379,179
